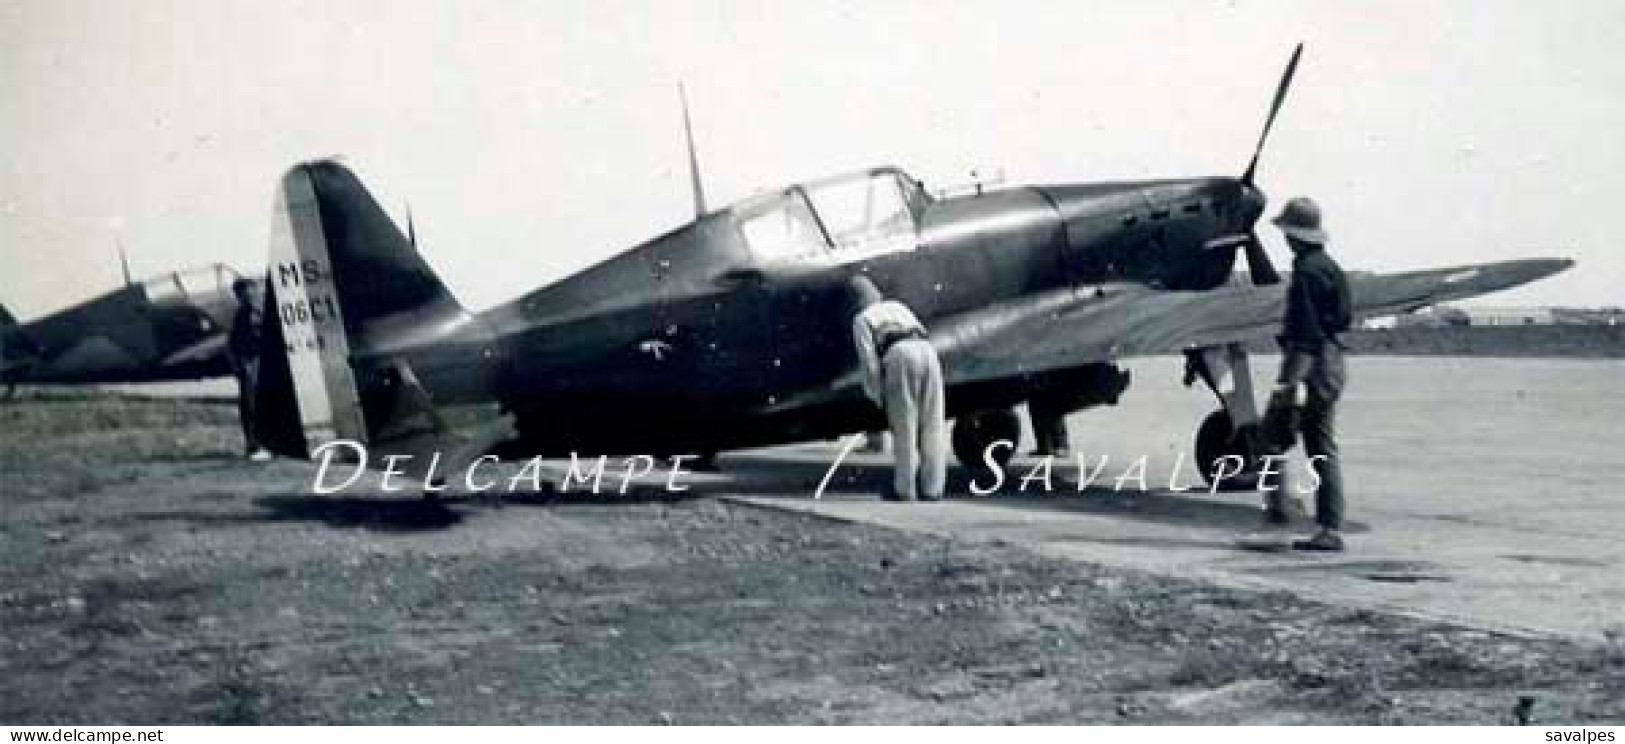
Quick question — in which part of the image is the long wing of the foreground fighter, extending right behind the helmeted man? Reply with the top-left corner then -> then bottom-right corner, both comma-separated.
931,258 -> 1573,385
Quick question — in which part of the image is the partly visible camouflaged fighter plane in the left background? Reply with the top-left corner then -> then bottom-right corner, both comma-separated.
0,263 -> 250,396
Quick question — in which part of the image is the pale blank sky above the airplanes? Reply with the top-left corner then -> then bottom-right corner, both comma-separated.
0,0 -> 1625,318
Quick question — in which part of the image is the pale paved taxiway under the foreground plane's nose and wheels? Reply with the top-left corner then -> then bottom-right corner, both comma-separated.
739,357 -> 1625,638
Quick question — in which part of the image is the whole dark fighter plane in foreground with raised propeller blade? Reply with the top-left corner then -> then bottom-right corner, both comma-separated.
255,44 -> 1573,487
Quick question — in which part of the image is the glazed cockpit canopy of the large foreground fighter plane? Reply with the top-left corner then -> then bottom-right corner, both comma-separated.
735,167 -> 930,263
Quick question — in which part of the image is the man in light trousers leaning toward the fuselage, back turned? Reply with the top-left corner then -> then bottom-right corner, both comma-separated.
850,275 -> 947,502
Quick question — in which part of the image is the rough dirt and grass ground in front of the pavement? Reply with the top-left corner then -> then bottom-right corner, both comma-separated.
0,391 -> 1625,725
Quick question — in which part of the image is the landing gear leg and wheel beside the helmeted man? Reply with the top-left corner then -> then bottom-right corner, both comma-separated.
1185,343 -> 1266,491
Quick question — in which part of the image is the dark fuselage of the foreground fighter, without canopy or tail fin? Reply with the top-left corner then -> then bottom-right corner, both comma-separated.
383,171 -> 1264,453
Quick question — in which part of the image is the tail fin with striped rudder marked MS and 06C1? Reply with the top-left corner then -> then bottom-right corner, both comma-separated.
254,161 -> 492,471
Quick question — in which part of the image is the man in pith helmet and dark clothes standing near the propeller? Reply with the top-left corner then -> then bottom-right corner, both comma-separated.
1264,197 -> 1354,551
